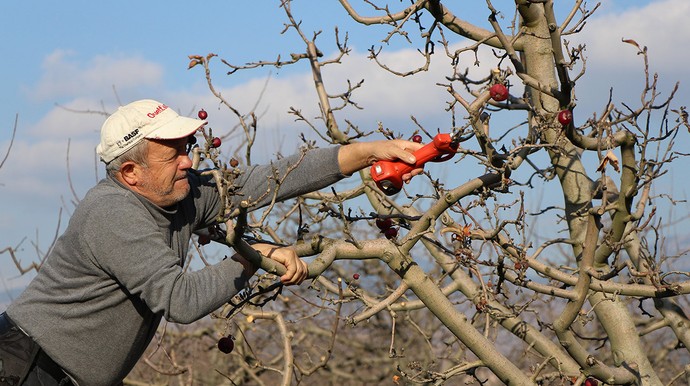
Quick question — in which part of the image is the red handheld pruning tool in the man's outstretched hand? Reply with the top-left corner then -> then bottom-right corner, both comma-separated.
371,134 -> 458,196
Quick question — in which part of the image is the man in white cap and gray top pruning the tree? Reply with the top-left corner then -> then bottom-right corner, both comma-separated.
0,100 -> 421,386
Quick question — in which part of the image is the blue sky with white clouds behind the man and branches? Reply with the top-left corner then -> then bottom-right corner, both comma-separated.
0,0 -> 690,308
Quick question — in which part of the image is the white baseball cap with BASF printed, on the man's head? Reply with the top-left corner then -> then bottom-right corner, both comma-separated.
96,99 -> 206,163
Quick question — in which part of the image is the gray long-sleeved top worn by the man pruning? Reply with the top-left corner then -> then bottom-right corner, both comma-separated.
7,148 -> 344,386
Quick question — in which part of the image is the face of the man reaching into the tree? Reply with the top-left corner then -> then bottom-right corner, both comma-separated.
137,138 -> 192,207
